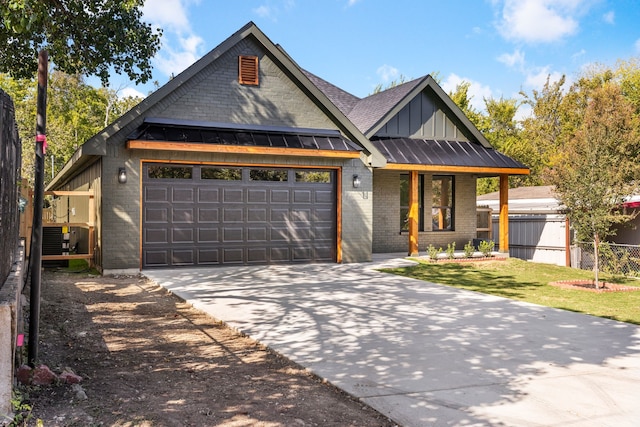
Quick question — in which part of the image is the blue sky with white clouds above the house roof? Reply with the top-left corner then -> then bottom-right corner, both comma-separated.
111,0 -> 640,118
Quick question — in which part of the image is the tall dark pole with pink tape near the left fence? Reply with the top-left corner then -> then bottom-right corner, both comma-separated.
27,50 -> 49,367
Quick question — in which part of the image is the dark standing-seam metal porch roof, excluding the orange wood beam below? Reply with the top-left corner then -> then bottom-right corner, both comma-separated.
371,138 -> 527,169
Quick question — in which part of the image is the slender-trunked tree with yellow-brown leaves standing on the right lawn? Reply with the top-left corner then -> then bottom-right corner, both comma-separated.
550,82 -> 640,288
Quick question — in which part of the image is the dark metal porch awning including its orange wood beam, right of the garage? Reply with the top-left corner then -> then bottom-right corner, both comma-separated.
371,138 -> 529,175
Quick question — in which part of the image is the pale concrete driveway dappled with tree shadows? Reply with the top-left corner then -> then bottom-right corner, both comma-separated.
143,257 -> 640,427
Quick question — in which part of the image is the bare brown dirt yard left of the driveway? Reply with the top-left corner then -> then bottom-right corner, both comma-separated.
20,270 -> 395,427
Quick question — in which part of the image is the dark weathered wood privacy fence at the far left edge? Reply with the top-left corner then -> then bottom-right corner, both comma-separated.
0,90 -> 22,287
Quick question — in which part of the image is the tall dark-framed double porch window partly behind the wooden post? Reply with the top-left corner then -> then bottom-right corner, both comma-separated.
400,175 -> 455,232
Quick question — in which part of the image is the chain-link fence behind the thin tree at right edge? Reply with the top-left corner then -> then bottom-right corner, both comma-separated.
571,242 -> 640,276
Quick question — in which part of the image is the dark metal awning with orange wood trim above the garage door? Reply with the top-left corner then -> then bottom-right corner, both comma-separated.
127,118 -> 362,158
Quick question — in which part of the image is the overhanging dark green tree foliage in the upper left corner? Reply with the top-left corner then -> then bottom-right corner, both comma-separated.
0,0 -> 161,86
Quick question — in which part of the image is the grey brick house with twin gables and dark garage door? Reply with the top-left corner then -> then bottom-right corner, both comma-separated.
47,23 -> 529,273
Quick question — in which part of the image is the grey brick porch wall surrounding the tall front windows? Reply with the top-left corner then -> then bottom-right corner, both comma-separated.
372,170 -> 477,254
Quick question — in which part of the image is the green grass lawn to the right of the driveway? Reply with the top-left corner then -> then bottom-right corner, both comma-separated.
382,258 -> 640,325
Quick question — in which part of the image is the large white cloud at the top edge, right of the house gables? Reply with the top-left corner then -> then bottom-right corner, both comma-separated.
494,0 -> 590,43
